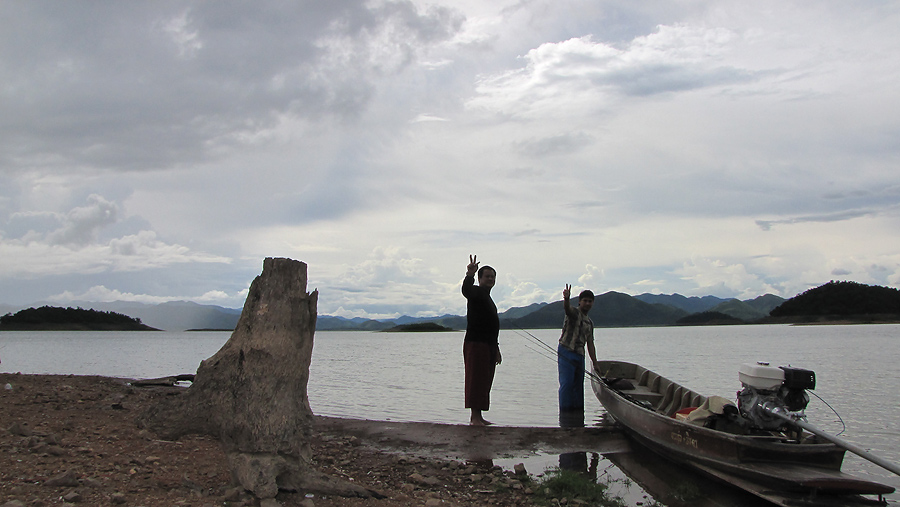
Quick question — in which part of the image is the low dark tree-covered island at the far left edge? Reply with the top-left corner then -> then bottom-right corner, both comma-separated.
0,306 -> 159,331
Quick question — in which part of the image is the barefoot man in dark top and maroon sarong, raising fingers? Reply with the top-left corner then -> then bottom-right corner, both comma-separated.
462,255 -> 502,426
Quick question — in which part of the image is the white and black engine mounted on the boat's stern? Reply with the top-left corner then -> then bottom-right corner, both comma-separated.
737,363 -> 816,430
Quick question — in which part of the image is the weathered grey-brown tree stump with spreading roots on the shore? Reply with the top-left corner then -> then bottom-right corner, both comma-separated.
138,258 -> 378,499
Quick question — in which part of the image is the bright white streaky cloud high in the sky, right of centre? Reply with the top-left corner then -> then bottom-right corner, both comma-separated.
469,25 -> 758,117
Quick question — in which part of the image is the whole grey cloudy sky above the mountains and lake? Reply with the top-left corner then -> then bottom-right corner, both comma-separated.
0,0 -> 900,317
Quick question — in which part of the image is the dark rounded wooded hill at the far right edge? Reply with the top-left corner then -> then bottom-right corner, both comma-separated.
770,281 -> 900,321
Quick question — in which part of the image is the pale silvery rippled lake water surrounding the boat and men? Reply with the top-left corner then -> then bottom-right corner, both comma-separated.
0,325 -> 900,504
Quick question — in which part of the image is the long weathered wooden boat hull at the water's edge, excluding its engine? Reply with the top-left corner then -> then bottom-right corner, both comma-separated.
591,361 -> 894,504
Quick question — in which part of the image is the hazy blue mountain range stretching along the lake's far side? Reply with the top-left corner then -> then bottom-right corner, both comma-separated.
0,292 -> 785,331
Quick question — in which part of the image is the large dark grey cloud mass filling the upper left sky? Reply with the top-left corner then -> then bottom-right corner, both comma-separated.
0,2 -> 461,172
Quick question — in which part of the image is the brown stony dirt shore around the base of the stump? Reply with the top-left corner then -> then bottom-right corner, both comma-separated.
0,373 -> 576,507
